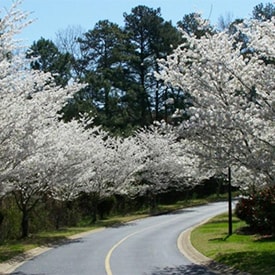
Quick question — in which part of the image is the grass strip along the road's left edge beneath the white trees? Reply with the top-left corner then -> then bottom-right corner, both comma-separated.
0,199 -> 211,263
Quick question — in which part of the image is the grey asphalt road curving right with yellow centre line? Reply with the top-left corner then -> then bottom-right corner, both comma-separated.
11,202 -> 227,275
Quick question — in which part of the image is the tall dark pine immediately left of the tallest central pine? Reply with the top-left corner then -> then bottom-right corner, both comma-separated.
73,20 -> 139,134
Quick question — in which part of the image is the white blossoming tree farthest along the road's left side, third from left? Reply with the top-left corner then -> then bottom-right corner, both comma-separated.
126,125 -> 198,211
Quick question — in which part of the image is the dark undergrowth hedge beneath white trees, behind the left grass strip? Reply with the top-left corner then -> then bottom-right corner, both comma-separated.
0,180 -> 235,243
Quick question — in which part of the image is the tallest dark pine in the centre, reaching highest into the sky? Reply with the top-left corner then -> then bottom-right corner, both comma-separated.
124,5 -> 181,125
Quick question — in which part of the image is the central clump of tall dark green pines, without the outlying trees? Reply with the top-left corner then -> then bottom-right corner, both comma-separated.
63,6 -> 184,135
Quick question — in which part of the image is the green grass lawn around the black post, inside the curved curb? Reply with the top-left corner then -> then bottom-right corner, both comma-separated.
191,214 -> 275,275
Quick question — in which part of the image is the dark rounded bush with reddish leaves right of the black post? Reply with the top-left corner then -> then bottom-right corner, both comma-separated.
236,186 -> 275,234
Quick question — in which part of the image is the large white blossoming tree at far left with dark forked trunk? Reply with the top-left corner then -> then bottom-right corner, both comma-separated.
0,3 -> 90,237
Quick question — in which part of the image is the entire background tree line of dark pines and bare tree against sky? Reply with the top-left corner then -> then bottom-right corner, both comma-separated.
28,4 -> 274,135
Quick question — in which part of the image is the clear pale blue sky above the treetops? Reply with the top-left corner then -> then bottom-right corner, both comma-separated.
0,0 -> 273,45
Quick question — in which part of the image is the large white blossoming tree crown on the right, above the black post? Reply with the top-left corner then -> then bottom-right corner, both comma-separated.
159,18 -> 275,190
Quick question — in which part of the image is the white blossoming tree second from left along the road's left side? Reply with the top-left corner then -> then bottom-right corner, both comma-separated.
72,128 -> 147,221
